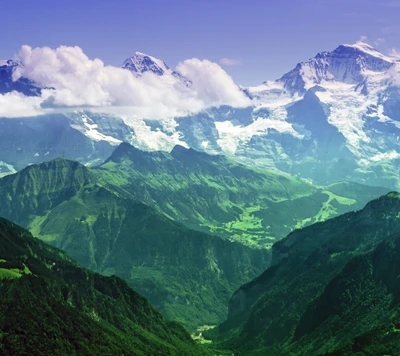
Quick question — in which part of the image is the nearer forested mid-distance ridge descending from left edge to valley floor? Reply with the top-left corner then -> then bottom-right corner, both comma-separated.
0,159 -> 270,327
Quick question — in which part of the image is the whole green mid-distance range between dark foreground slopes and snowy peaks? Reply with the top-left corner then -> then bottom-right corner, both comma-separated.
0,143 -> 387,328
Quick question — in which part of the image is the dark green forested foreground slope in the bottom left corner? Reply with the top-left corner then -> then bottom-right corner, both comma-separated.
0,219 -> 208,356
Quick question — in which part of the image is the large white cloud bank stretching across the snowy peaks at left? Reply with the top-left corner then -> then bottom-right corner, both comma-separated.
0,45 -> 251,118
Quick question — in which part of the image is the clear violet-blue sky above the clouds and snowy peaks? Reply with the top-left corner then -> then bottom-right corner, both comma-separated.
0,0 -> 400,85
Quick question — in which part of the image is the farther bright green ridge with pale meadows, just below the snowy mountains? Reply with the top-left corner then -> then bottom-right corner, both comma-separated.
92,143 -> 388,247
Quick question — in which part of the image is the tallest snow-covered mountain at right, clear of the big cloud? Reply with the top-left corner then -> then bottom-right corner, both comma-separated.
176,43 -> 400,189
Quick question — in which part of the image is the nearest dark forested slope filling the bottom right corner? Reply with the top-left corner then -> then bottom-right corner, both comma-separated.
291,233 -> 400,355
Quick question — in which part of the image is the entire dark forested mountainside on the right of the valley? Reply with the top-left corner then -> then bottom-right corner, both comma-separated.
208,193 -> 400,355
